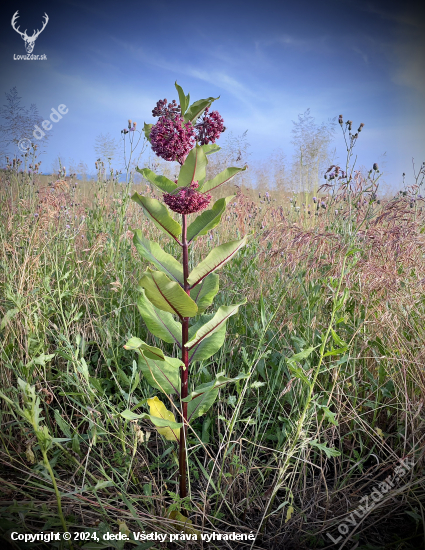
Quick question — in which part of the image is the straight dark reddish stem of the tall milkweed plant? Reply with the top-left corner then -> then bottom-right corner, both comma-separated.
179,214 -> 190,498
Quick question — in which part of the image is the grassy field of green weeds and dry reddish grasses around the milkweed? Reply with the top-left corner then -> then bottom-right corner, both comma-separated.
0,151 -> 425,550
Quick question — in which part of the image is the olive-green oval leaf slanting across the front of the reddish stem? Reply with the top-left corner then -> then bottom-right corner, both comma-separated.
139,269 -> 198,317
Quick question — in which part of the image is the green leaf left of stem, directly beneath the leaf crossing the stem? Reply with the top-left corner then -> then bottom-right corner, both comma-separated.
137,289 -> 182,348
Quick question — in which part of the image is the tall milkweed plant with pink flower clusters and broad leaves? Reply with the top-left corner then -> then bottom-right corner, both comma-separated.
122,82 -> 248,498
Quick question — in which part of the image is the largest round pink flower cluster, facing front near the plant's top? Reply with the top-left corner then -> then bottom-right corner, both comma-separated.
150,115 -> 195,164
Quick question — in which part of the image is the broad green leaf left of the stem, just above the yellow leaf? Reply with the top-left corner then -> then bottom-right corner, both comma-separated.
139,348 -> 184,395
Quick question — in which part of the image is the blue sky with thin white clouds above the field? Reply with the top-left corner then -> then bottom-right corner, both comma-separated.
0,0 -> 425,192
